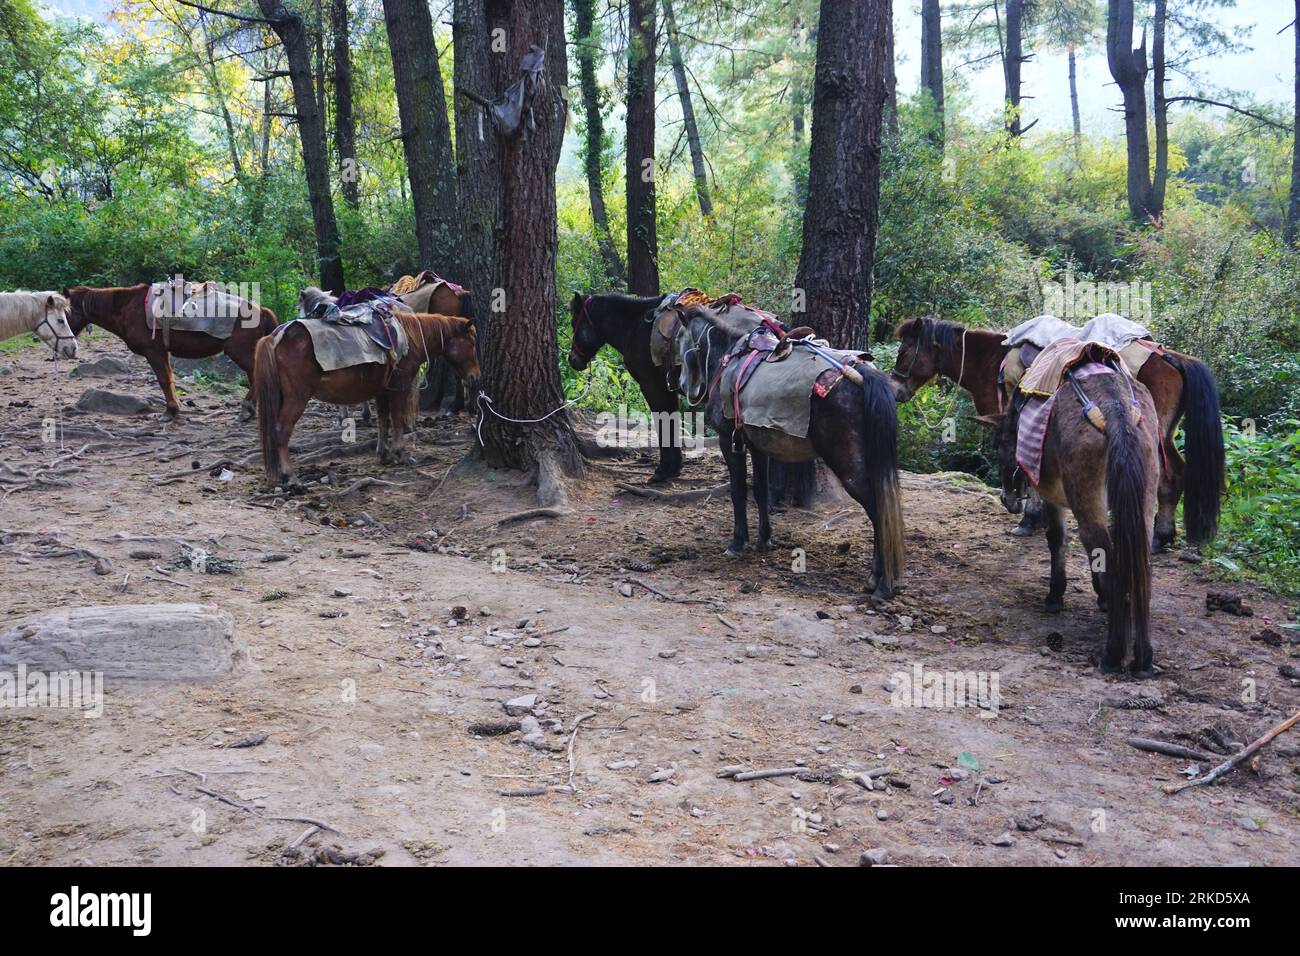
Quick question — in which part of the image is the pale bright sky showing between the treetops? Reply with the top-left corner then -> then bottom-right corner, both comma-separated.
46,0 -> 1295,137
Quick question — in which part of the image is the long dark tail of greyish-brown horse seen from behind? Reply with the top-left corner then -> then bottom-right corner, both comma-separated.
1102,398 -> 1156,671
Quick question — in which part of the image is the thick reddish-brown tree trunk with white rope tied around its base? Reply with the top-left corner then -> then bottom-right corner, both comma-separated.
455,0 -> 581,489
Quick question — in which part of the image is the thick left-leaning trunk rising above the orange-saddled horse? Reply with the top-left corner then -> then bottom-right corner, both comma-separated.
384,0 -> 460,276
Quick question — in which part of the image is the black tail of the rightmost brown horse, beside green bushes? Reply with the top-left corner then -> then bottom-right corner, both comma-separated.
1175,355 -> 1223,545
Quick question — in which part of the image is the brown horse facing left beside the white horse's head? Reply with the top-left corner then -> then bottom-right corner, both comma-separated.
65,285 -> 276,421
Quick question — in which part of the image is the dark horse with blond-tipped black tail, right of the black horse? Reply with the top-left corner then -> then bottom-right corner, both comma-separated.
676,310 -> 904,600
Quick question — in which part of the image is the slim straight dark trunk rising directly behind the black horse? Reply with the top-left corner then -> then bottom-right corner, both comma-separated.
627,0 -> 659,295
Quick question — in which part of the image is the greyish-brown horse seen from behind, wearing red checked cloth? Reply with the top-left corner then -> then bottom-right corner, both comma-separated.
980,372 -> 1161,678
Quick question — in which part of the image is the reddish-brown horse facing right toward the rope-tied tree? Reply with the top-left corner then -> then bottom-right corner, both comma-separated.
254,312 -> 478,486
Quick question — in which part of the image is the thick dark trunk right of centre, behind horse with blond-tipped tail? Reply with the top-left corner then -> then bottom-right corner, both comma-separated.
796,0 -> 892,349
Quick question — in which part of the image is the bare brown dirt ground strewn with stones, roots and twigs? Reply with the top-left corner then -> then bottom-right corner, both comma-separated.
0,334 -> 1300,866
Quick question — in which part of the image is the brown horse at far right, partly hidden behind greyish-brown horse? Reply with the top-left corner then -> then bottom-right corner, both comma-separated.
892,316 -> 1223,550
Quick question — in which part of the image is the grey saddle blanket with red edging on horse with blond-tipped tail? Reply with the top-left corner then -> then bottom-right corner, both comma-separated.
719,329 -> 866,438
